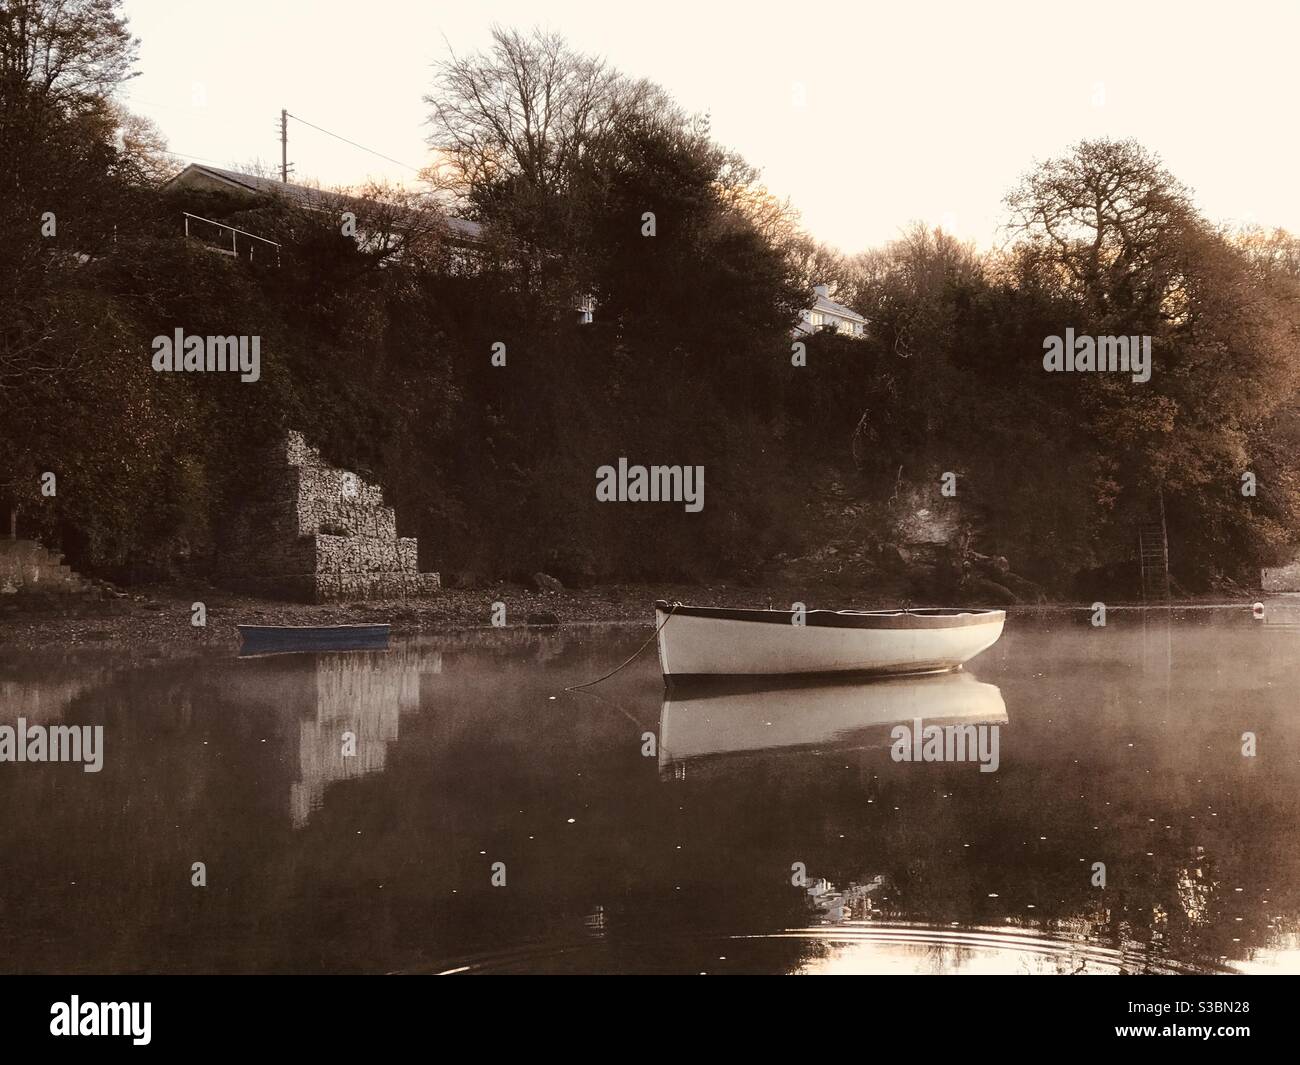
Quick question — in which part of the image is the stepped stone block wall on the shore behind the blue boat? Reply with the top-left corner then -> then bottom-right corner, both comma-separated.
218,430 -> 439,602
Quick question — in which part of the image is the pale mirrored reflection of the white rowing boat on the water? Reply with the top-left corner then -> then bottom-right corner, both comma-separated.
659,671 -> 1006,767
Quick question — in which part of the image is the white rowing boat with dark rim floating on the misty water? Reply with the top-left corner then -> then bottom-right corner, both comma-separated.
654,599 -> 1006,677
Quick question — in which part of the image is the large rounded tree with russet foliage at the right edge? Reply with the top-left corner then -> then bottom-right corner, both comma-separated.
1008,140 -> 1300,580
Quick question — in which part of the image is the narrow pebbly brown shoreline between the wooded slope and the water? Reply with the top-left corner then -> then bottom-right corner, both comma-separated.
0,583 -> 1260,651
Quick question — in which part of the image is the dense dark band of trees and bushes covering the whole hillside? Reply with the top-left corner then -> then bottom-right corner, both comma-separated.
0,10 -> 1300,592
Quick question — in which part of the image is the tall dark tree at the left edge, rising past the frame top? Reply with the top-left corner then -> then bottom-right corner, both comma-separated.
0,0 -> 137,540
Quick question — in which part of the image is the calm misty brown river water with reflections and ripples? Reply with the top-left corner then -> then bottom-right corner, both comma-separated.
0,605 -> 1300,973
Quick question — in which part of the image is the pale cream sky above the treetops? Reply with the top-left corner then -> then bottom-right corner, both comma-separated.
114,0 -> 1300,252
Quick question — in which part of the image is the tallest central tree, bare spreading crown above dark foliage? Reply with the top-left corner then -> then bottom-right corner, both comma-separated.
429,30 -> 807,577
